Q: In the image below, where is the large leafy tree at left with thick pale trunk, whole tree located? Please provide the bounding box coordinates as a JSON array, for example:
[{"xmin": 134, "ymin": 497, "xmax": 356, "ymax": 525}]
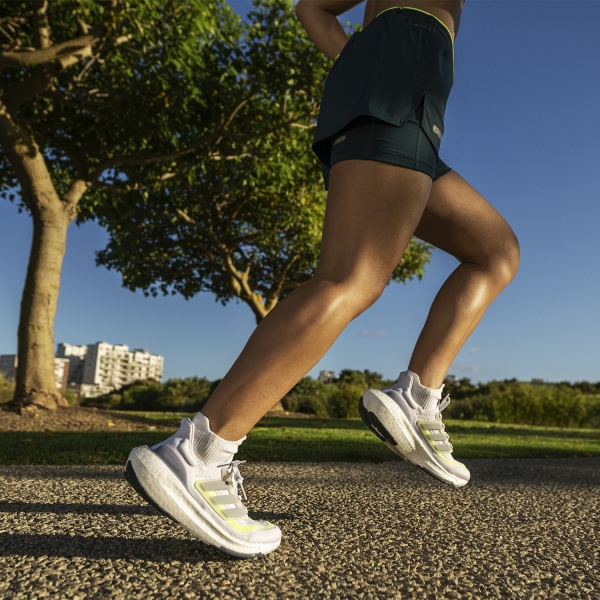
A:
[{"xmin": 0, "ymin": 0, "xmax": 282, "ymax": 408}]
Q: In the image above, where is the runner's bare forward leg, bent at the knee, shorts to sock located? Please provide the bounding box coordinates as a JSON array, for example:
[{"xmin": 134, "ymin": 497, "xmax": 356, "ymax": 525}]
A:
[{"xmin": 408, "ymin": 171, "xmax": 519, "ymax": 388}]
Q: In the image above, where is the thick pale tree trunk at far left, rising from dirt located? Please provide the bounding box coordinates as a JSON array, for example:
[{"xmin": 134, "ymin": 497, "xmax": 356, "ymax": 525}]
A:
[{"xmin": 0, "ymin": 103, "xmax": 76, "ymax": 409}]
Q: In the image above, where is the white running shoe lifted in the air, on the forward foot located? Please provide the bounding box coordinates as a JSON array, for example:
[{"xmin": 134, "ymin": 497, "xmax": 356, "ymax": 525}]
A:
[{"xmin": 359, "ymin": 371, "xmax": 471, "ymax": 487}]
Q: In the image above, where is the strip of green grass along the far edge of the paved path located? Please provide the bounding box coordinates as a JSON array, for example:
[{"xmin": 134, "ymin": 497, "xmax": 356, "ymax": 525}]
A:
[{"xmin": 0, "ymin": 412, "xmax": 600, "ymax": 465}]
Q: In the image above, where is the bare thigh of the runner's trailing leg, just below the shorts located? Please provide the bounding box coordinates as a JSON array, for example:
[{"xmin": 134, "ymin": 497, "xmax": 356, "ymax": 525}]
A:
[{"xmin": 316, "ymin": 160, "xmax": 431, "ymax": 285}]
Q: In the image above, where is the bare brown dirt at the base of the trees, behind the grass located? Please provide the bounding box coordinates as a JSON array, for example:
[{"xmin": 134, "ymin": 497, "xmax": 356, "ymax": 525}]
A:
[{"xmin": 0, "ymin": 406, "xmax": 314, "ymax": 431}]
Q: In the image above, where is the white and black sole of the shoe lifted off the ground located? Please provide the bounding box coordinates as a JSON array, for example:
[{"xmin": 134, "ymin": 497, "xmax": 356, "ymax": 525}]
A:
[{"xmin": 358, "ymin": 390, "xmax": 469, "ymax": 487}]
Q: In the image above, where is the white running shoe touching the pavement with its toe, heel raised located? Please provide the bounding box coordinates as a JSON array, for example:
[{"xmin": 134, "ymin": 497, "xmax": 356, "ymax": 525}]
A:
[{"xmin": 125, "ymin": 419, "xmax": 281, "ymax": 558}]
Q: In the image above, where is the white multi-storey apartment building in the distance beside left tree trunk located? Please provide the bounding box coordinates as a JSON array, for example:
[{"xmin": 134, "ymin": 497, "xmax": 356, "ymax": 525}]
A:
[{"xmin": 57, "ymin": 342, "xmax": 164, "ymax": 398}]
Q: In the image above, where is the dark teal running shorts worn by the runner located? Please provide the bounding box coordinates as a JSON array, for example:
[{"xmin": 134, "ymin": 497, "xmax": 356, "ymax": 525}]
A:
[{"xmin": 312, "ymin": 8, "xmax": 454, "ymax": 189}]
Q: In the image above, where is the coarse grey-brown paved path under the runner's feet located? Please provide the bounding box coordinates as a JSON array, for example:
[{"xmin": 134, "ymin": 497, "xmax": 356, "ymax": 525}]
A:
[{"xmin": 0, "ymin": 458, "xmax": 600, "ymax": 600}]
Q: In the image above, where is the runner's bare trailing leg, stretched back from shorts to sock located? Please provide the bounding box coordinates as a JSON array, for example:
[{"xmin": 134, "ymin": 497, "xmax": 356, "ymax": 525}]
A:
[{"xmin": 202, "ymin": 160, "xmax": 432, "ymax": 440}]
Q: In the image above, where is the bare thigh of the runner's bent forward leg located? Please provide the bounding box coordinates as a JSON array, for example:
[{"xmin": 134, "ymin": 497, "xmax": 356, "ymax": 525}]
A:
[{"xmin": 414, "ymin": 171, "xmax": 519, "ymax": 270}]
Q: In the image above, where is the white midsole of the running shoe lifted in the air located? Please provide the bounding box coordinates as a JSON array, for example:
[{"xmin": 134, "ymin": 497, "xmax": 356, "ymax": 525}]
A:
[{"xmin": 362, "ymin": 390, "xmax": 468, "ymax": 487}]
